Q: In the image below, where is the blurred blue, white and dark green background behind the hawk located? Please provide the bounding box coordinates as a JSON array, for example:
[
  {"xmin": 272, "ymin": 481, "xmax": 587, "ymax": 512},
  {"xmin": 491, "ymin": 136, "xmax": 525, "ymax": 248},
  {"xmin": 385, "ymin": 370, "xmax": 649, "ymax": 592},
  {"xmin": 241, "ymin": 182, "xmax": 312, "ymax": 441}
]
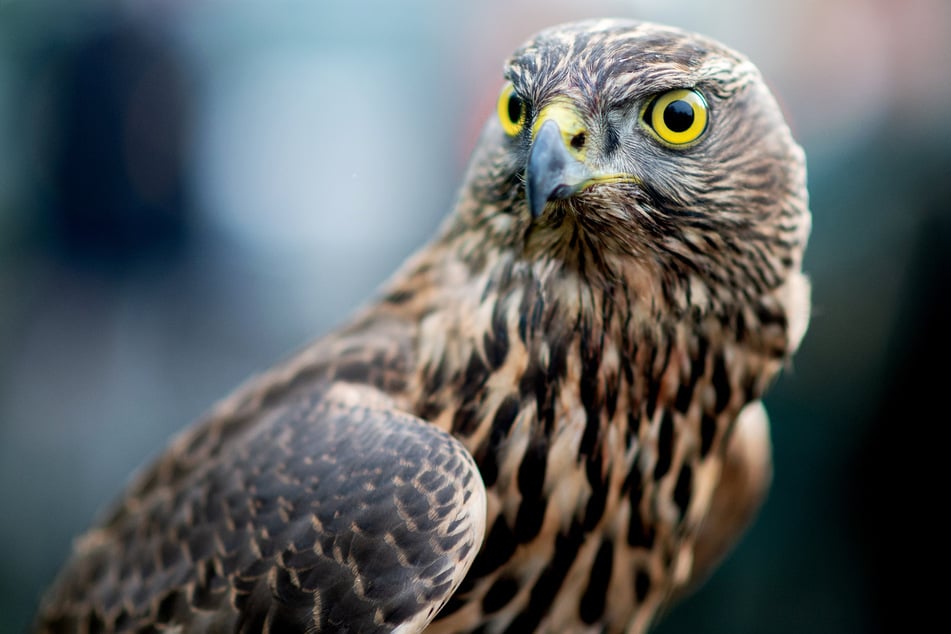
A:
[{"xmin": 0, "ymin": 0, "xmax": 951, "ymax": 634}]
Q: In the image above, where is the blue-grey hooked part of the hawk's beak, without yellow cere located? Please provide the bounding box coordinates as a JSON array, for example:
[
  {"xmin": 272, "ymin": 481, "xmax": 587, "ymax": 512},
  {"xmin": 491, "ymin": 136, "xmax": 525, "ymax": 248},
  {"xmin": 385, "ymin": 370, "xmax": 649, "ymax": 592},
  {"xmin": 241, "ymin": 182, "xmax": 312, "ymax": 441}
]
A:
[{"xmin": 525, "ymin": 118, "xmax": 593, "ymax": 218}]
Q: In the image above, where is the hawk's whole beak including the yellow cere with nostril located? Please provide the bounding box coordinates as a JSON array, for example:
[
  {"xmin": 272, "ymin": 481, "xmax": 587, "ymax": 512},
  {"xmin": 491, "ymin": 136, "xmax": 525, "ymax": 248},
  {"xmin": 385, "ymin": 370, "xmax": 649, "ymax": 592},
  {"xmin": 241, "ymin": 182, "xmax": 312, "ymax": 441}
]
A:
[{"xmin": 525, "ymin": 103, "xmax": 593, "ymax": 218}]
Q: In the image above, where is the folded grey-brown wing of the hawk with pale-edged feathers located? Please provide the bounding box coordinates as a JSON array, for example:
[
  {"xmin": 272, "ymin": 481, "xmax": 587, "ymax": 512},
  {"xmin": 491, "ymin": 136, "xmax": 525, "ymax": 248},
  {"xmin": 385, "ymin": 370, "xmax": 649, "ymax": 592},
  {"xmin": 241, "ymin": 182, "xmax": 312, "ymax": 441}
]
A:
[{"xmin": 39, "ymin": 384, "xmax": 485, "ymax": 632}]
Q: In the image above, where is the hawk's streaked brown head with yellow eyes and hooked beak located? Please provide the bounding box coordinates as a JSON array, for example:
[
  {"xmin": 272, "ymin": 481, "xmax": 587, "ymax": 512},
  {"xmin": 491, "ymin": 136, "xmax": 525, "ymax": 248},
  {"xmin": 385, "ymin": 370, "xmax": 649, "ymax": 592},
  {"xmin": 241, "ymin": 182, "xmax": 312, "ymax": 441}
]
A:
[{"xmin": 451, "ymin": 20, "xmax": 810, "ymax": 326}]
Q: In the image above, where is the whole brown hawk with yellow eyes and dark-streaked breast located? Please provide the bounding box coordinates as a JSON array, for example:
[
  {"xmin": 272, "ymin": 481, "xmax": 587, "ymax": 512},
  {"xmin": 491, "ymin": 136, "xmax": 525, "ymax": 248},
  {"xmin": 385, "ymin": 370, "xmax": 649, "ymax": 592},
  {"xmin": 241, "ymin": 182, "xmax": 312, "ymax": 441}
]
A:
[{"xmin": 35, "ymin": 20, "xmax": 811, "ymax": 633}]
